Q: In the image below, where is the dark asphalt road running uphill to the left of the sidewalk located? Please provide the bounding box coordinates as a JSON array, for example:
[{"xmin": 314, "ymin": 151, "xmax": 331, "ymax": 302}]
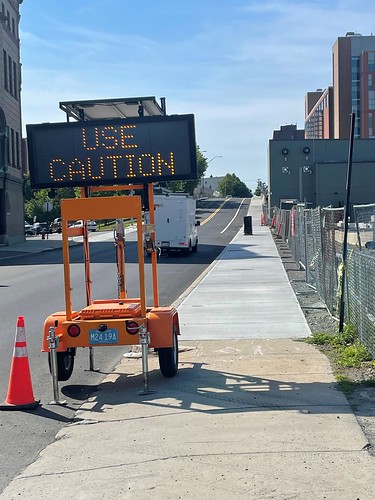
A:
[{"xmin": 0, "ymin": 198, "xmax": 253, "ymax": 492}]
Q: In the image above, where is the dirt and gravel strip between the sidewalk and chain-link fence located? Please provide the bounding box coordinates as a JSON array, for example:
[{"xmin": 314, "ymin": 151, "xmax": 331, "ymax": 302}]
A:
[{"xmin": 275, "ymin": 233, "xmax": 375, "ymax": 456}]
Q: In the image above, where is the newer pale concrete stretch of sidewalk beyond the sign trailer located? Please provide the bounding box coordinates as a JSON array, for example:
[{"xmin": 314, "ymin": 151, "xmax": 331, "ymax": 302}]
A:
[{"xmin": 179, "ymin": 199, "xmax": 310, "ymax": 340}]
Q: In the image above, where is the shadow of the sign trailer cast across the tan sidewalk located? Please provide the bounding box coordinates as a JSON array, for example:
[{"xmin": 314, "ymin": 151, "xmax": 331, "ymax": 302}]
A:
[{"xmin": 68, "ymin": 363, "xmax": 352, "ymax": 419}]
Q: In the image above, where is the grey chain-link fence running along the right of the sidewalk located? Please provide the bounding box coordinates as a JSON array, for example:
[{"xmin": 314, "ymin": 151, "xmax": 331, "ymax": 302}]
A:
[{"xmin": 269, "ymin": 204, "xmax": 375, "ymax": 356}]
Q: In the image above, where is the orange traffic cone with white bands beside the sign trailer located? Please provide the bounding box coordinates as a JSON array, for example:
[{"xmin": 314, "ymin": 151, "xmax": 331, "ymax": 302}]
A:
[{"xmin": 0, "ymin": 316, "xmax": 39, "ymax": 410}]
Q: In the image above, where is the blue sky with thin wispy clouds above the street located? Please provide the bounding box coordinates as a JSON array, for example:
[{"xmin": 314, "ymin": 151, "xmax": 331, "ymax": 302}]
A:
[{"xmin": 20, "ymin": 0, "xmax": 375, "ymax": 189}]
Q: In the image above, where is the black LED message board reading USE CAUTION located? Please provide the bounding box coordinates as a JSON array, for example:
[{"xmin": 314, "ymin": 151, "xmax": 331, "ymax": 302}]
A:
[{"xmin": 26, "ymin": 115, "xmax": 197, "ymax": 189}]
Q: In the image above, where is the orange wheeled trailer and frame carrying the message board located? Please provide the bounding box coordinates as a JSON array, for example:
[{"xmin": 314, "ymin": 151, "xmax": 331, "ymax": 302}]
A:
[{"xmin": 42, "ymin": 184, "xmax": 180, "ymax": 383}]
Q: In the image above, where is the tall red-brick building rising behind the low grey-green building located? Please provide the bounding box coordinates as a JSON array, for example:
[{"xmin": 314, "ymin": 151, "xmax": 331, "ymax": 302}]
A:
[{"xmin": 305, "ymin": 31, "xmax": 375, "ymax": 139}]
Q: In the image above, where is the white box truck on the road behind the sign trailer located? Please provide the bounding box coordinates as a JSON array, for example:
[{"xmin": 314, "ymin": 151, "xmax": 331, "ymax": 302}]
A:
[{"xmin": 146, "ymin": 193, "xmax": 199, "ymax": 252}]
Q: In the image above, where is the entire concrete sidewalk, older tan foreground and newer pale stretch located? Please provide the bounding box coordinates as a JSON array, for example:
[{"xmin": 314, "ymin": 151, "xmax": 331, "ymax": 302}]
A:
[{"xmin": 0, "ymin": 200, "xmax": 375, "ymax": 500}]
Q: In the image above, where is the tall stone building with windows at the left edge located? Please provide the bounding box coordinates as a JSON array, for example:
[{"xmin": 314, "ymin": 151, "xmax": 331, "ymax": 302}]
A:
[{"xmin": 0, "ymin": 0, "xmax": 25, "ymax": 245}]
